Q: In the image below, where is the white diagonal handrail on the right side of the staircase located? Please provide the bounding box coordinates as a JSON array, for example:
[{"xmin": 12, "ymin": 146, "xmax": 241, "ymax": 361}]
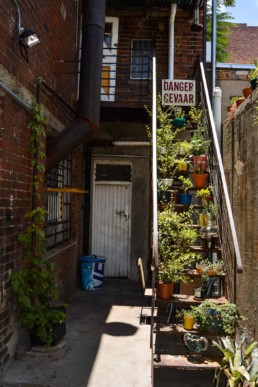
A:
[{"xmin": 200, "ymin": 63, "xmax": 243, "ymax": 273}]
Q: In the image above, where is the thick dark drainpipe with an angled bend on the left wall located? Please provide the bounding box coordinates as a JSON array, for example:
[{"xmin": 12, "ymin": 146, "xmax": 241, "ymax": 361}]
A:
[{"xmin": 46, "ymin": 0, "xmax": 106, "ymax": 171}]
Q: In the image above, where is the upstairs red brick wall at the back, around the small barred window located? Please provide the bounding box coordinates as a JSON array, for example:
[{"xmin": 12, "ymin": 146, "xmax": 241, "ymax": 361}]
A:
[{"xmin": 107, "ymin": 8, "xmax": 203, "ymax": 99}]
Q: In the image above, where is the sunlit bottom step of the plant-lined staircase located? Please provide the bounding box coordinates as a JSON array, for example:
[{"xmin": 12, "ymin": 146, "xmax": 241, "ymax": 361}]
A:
[{"xmin": 153, "ymin": 355, "xmax": 220, "ymax": 370}]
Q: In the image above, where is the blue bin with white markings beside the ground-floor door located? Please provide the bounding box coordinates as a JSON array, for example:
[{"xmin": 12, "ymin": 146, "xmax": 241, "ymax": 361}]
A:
[{"xmin": 80, "ymin": 255, "xmax": 106, "ymax": 291}]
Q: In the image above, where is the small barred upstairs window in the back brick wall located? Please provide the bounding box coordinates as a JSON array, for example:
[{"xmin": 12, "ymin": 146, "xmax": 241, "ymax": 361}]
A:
[{"xmin": 131, "ymin": 40, "xmax": 153, "ymax": 79}]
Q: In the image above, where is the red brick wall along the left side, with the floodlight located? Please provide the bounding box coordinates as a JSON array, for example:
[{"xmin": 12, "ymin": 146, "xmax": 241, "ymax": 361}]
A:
[{"xmin": 0, "ymin": 0, "xmax": 84, "ymax": 371}]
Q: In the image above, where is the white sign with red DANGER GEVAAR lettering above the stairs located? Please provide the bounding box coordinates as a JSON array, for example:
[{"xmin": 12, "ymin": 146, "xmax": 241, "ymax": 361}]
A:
[{"xmin": 162, "ymin": 79, "xmax": 195, "ymax": 106}]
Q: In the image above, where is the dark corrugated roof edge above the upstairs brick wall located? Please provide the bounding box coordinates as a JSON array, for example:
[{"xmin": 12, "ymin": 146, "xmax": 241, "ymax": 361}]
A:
[{"xmin": 106, "ymin": 0, "xmax": 204, "ymax": 8}]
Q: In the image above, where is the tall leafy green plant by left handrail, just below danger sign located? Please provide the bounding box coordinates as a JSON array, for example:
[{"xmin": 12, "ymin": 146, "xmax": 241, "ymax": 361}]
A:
[{"xmin": 145, "ymin": 94, "xmax": 181, "ymax": 178}]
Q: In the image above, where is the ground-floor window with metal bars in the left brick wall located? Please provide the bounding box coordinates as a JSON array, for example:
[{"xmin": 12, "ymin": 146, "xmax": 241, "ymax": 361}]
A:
[{"xmin": 45, "ymin": 158, "xmax": 72, "ymax": 248}]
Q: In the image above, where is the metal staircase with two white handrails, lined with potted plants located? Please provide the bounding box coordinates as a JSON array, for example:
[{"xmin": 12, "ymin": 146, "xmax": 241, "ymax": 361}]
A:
[{"xmin": 150, "ymin": 58, "xmax": 242, "ymax": 386}]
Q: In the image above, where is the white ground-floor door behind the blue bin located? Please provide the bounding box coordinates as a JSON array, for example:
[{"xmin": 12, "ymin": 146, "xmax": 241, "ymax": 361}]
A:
[{"xmin": 91, "ymin": 164, "xmax": 131, "ymax": 277}]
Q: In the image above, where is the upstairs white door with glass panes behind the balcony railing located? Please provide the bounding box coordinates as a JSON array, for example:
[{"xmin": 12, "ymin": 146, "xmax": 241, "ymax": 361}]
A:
[{"xmin": 101, "ymin": 17, "xmax": 118, "ymax": 101}]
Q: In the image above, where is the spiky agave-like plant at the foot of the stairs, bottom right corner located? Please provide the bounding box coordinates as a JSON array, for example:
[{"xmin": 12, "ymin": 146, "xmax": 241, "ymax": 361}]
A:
[{"xmin": 213, "ymin": 335, "xmax": 258, "ymax": 387}]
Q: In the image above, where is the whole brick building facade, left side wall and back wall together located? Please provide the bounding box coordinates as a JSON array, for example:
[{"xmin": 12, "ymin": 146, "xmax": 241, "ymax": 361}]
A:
[{"xmin": 0, "ymin": 0, "xmax": 206, "ymax": 376}]
